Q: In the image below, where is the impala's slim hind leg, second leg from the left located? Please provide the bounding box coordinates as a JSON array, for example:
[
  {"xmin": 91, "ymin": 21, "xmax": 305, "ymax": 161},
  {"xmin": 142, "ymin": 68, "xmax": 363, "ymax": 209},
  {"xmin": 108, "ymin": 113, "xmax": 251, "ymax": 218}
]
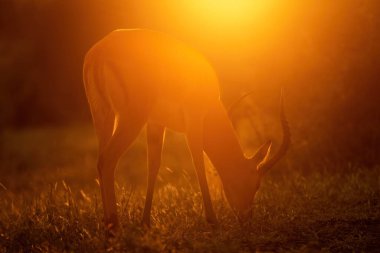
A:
[{"xmin": 142, "ymin": 124, "xmax": 165, "ymax": 227}]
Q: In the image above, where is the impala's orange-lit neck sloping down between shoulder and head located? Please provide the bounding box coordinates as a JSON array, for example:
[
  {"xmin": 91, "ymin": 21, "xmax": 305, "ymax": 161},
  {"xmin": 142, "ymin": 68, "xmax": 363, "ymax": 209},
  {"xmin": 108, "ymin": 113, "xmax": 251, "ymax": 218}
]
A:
[{"xmin": 204, "ymin": 102, "xmax": 249, "ymax": 182}]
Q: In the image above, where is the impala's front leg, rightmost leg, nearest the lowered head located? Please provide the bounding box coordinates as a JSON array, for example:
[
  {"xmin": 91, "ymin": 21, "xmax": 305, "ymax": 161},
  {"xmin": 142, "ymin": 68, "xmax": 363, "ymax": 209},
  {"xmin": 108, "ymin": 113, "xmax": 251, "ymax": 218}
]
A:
[{"xmin": 187, "ymin": 115, "xmax": 218, "ymax": 225}]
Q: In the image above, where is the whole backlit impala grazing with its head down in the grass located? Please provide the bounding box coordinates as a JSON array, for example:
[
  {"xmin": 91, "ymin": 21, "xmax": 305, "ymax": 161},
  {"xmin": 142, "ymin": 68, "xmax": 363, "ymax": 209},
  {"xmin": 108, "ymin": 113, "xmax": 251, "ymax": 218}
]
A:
[{"xmin": 83, "ymin": 29, "xmax": 290, "ymax": 227}]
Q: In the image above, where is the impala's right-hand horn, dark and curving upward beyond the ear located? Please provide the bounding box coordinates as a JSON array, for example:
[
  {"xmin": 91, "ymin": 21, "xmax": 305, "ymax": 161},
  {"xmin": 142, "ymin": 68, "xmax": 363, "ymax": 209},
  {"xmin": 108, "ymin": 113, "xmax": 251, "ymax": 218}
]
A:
[{"xmin": 257, "ymin": 89, "xmax": 291, "ymax": 175}]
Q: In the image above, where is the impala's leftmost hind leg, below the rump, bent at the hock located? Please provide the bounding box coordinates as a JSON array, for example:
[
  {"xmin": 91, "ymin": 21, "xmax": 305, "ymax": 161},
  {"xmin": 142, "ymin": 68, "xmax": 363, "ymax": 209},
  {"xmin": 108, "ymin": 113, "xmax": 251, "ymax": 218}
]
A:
[{"xmin": 98, "ymin": 115, "xmax": 145, "ymax": 229}]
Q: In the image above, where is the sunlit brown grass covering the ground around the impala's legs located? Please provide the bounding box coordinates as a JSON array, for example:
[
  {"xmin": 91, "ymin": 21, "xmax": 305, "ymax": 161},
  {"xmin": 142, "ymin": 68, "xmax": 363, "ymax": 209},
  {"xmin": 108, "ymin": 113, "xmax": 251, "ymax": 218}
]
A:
[{"xmin": 0, "ymin": 127, "xmax": 380, "ymax": 252}]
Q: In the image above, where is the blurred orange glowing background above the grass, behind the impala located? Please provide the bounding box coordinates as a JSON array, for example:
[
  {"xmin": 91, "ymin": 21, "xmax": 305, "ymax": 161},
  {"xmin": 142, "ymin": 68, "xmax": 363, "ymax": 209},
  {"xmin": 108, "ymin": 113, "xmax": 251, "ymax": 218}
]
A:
[{"xmin": 0, "ymin": 0, "xmax": 380, "ymax": 174}]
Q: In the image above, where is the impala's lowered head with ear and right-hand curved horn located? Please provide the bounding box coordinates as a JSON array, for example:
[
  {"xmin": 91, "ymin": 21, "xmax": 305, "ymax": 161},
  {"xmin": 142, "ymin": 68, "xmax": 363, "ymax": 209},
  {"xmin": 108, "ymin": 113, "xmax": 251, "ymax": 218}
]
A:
[{"xmin": 224, "ymin": 92, "xmax": 290, "ymax": 222}]
